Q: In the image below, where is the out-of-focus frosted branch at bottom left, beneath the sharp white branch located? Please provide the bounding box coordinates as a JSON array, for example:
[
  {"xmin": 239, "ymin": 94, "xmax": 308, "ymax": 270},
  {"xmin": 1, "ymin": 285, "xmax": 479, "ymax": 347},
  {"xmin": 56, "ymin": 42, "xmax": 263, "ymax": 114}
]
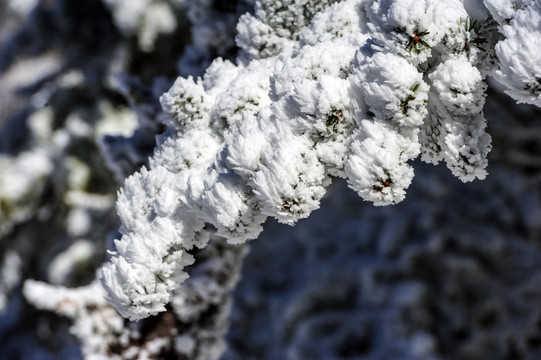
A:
[{"xmin": 23, "ymin": 237, "xmax": 247, "ymax": 360}]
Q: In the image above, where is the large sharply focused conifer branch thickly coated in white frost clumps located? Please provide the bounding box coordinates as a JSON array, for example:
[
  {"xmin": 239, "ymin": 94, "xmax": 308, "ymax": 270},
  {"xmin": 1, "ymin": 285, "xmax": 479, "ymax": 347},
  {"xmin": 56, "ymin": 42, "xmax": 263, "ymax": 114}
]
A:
[{"xmin": 101, "ymin": 0, "xmax": 540, "ymax": 320}]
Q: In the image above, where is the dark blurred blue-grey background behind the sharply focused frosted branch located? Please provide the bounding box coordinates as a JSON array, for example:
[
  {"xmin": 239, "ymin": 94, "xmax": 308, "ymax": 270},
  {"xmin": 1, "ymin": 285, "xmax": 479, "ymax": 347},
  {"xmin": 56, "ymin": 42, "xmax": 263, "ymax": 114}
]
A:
[{"xmin": 0, "ymin": 0, "xmax": 541, "ymax": 360}]
